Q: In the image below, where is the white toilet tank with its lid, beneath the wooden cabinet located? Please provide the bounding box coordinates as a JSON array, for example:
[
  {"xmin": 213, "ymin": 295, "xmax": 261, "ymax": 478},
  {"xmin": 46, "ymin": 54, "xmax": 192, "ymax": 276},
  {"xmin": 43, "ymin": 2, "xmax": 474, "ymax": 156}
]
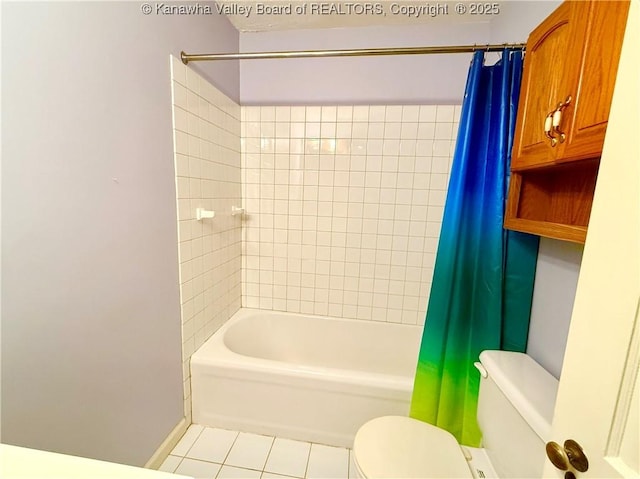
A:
[{"xmin": 478, "ymin": 351, "xmax": 558, "ymax": 478}]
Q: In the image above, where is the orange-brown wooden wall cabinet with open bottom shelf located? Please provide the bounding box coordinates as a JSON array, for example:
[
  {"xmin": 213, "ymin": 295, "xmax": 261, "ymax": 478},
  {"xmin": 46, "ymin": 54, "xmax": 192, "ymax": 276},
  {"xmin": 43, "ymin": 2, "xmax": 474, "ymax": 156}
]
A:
[{"xmin": 505, "ymin": 0, "xmax": 629, "ymax": 243}]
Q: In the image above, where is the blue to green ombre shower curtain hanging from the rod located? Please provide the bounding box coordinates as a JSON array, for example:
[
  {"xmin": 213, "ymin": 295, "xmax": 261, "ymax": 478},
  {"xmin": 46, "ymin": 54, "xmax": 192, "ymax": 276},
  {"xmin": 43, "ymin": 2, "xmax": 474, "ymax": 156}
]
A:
[{"xmin": 410, "ymin": 50, "xmax": 538, "ymax": 446}]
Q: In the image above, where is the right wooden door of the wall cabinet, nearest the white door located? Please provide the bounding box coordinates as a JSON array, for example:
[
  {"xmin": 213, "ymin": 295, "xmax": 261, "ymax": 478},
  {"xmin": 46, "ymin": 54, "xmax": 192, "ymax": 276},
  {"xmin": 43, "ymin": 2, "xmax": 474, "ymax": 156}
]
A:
[{"xmin": 556, "ymin": 1, "xmax": 629, "ymax": 162}]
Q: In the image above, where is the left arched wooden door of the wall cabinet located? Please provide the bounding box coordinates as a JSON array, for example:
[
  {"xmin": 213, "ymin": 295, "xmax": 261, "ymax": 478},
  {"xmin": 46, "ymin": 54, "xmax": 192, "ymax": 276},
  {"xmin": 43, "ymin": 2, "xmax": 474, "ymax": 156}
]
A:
[{"xmin": 511, "ymin": 2, "xmax": 584, "ymax": 170}]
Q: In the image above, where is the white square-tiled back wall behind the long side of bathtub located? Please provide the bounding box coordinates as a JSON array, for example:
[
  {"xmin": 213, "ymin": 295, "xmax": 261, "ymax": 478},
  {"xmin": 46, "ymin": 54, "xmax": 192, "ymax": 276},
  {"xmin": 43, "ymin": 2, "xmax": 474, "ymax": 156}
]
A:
[{"xmin": 242, "ymin": 105, "xmax": 460, "ymax": 324}]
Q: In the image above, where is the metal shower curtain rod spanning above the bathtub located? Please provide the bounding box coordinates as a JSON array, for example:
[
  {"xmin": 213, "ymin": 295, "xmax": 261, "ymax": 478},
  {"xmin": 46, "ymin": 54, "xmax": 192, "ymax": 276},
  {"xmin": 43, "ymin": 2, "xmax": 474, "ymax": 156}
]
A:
[{"xmin": 180, "ymin": 43, "xmax": 526, "ymax": 65}]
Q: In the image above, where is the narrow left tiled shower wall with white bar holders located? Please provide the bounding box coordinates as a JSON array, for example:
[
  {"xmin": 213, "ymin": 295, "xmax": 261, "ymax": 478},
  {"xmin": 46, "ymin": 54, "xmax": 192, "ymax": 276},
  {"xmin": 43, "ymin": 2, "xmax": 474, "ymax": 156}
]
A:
[{"xmin": 171, "ymin": 57, "xmax": 242, "ymax": 420}]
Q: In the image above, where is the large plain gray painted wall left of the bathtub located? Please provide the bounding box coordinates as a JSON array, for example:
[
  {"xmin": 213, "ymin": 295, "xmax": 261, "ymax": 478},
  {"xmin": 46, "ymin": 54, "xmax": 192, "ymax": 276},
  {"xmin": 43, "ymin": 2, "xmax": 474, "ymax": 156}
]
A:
[{"xmin": 2, "ymin": 2, "xmax": 239, "ymax": 465}]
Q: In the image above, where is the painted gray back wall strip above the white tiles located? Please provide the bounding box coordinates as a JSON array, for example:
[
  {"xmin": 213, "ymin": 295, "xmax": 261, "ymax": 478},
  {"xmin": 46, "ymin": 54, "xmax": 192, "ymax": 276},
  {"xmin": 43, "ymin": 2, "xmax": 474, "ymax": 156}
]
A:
[{"xmin": 240, "ymin": 23, "xmax": 489, "ymax": 105}]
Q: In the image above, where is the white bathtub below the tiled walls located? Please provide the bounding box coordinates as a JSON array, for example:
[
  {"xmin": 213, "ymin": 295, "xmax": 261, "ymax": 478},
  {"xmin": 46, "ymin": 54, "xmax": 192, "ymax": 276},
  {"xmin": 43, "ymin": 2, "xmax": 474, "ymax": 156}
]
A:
[{"xmin": 191, "ymin": 308, "xmax": 422, "ymax": 447}]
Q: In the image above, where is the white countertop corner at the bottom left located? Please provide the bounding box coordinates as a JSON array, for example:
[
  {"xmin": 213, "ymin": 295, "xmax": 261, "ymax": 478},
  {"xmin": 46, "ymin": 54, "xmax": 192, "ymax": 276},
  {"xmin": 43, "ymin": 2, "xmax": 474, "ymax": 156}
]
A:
[{"xmin": 0, "ymin": 444, "xmax": 193, "ymax": 479}]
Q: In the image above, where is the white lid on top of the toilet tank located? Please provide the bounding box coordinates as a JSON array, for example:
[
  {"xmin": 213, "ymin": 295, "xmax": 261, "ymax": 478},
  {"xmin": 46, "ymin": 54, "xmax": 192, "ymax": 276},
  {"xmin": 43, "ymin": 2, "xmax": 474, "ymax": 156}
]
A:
[{"xmin": 480, "ymin": 351, "xmax": 558, "ymax": 442}]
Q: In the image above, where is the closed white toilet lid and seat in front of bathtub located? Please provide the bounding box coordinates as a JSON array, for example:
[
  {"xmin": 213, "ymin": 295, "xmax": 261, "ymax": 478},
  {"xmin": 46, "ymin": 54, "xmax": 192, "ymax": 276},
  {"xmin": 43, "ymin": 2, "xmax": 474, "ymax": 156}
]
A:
[{"xmin": 353, "ymin": 416, "xmax": 473, "ymax": 479}]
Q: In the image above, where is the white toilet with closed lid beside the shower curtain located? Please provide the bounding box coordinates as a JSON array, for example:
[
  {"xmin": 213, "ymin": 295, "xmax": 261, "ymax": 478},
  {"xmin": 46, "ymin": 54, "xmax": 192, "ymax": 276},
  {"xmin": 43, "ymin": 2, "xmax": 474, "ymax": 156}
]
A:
[{"xmin": 353, "ymin": 351, "xmax": 558, "ymax": 479}]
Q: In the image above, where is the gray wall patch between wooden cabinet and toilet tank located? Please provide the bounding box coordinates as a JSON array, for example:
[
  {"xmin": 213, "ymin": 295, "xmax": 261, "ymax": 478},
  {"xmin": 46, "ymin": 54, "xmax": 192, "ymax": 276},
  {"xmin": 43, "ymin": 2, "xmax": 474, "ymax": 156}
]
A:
[{"xmin": 527, "ymin": 238, "xmax": 584, "ymax": 378}]
